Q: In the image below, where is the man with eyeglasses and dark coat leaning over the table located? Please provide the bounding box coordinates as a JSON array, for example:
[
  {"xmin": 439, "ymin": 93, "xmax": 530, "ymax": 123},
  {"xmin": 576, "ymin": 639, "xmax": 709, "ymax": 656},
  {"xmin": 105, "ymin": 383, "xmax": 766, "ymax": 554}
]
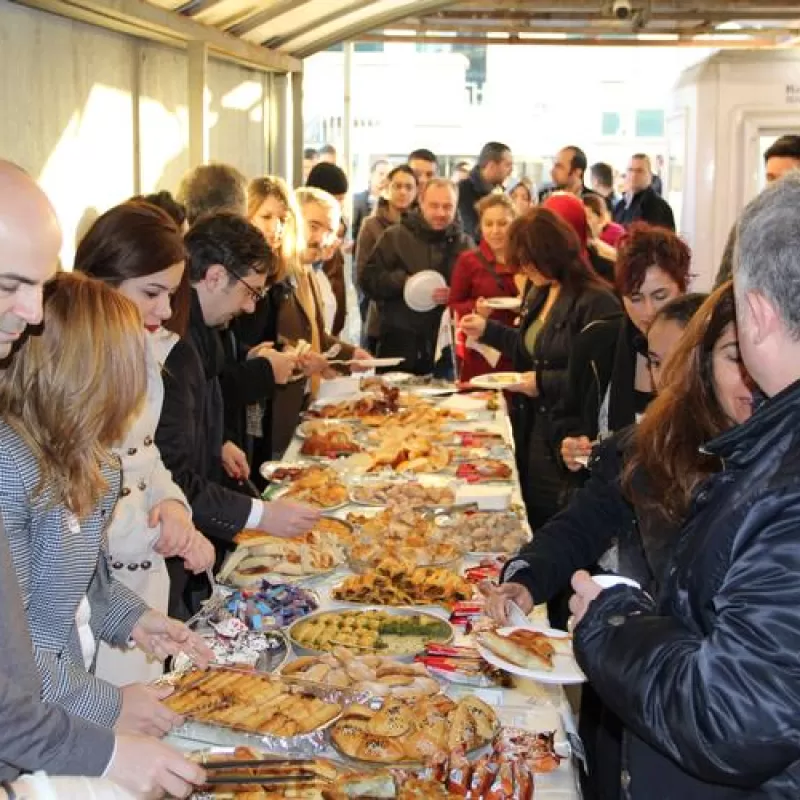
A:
[{"xmin": 156, "ymin": 212, "xmax": 319, "ymax": 618}]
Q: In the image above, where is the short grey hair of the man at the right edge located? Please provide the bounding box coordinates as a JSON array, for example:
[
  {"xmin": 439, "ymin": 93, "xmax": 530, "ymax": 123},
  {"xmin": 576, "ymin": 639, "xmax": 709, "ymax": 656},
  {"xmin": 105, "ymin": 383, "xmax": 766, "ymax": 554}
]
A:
[{"xmin": 733, "ymin": 170, "xmax": 800, "ymax": 340}]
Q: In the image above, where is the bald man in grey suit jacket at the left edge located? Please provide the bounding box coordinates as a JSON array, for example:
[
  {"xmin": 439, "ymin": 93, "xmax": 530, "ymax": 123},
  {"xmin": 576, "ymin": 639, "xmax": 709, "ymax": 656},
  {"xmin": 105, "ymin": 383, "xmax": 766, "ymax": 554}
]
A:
[{"xmin": 0, "ymin": 160, "xmax": 203, "ymax": 797}]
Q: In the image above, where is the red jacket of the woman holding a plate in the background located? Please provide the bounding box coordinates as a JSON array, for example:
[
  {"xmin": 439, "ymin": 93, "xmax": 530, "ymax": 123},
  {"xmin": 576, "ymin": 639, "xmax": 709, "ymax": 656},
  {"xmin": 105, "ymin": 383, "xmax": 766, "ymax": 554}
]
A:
[{"xmin": 449, "ymin": 241, "xmax": 518, "ymax": 381}]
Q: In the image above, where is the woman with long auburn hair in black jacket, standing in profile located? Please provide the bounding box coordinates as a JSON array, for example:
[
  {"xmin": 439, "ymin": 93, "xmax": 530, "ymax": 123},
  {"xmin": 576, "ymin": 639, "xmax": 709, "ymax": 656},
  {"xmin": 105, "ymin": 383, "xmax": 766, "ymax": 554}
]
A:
[{"xmin": 461, "ymin": 206, "xmax": 619, "ymax": 528}]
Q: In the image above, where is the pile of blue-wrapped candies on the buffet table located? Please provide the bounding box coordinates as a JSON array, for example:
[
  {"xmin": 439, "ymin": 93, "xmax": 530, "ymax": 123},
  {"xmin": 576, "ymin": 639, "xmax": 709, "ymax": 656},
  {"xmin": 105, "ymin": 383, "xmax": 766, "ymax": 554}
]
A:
[{"xmin": 226, "ymin": 580, "xmax": 319, "ymax": 632}]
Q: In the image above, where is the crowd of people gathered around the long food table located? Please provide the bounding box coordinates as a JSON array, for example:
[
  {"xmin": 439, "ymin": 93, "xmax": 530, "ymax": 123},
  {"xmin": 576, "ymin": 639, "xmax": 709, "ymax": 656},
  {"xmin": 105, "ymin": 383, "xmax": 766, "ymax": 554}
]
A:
[{"xmin": 0, "ymin": 131, "xmax": 800, "ymax": 800}]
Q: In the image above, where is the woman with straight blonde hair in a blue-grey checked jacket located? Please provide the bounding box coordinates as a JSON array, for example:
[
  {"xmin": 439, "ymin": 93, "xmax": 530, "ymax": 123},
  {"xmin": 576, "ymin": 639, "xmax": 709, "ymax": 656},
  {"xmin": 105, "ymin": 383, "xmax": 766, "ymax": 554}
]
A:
[{"xmin": 0, "ymin": 273, "xmax": 210, "ymax": 735}]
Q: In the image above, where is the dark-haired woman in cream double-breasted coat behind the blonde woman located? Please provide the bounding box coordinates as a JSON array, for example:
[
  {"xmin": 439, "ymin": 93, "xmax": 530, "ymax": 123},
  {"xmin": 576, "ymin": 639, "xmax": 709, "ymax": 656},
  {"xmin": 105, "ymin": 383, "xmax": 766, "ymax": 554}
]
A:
[{"xmin": 75, "ymin": 201, "xmax": 214, "ymax": 686}]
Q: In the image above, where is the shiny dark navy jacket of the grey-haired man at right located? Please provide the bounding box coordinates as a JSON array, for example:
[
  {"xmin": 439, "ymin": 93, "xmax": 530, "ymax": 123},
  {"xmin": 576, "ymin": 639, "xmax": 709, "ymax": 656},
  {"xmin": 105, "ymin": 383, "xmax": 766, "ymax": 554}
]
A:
[{"xmin": 575, "ymin": 382, "xmax": 800, "ymax": 800}]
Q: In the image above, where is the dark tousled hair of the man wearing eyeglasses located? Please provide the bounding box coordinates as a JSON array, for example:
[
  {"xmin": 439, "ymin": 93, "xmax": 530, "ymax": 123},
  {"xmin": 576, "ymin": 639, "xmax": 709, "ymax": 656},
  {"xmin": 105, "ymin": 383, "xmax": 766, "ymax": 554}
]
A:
[{"xmin": 184, "ymin": 211, "xmax": 277, "ymax": 283}]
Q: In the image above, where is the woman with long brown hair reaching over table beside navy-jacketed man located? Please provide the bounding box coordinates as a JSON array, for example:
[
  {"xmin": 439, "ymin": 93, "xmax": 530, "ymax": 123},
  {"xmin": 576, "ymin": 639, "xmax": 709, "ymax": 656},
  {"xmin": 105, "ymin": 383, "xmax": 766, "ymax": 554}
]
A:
[{"xmin": 483, "ymin": 283, "xmax": 753, "ymax": 800}]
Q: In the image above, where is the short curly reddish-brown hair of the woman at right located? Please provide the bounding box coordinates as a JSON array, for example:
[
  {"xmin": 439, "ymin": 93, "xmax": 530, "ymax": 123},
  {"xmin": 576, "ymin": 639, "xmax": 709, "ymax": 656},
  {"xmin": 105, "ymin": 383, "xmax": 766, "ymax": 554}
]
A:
[{"xmin": 614, "ymin": 222, "xmax": 692, "ymax": 297}]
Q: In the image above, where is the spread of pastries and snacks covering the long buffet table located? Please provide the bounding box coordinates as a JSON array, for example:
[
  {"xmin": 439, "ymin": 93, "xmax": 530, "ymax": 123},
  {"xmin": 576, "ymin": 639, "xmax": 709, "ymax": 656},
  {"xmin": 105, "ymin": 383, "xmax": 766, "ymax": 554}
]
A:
[{"xmin": 179, "ymin": 378, "xmax": 577, "ymax": 800}]
